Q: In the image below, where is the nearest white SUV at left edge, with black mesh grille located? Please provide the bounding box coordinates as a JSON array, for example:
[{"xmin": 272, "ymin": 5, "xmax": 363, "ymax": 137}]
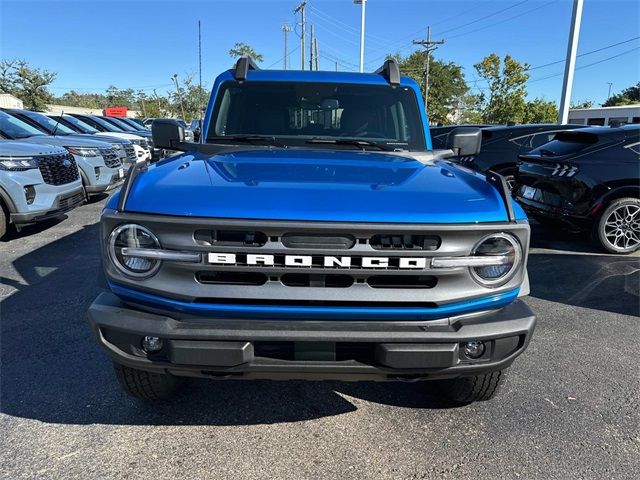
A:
[{"xmin": 0, "ymin": 140, "xmax": 85, "ymax": 238}]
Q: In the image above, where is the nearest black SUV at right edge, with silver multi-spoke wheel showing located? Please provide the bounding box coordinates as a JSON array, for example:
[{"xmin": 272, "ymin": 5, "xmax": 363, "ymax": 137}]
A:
[{"xmin": 514, "ymin": 125, "xmax": 640, "ymax": 254}]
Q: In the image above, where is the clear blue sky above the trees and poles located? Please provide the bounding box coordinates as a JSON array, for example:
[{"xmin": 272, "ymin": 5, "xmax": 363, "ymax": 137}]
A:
[{"xmin": 0, "ymin": 0, "xmax": 640, "ymax": 103}]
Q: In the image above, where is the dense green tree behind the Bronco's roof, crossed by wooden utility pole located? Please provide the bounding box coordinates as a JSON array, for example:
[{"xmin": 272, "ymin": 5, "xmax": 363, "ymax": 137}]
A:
[{"xmin": 387, "ymin": 51, "xmax": 469, "ymax": 124}]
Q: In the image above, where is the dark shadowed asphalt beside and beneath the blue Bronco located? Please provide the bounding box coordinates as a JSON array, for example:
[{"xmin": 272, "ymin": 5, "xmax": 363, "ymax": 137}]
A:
[{"xmin": 0, "ymin": 219, "xmax": 640, "ymax": 425}]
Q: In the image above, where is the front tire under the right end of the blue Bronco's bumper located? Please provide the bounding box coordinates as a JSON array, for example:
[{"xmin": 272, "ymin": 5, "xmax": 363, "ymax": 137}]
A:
[{"xmin": 438, "ymin": 370, "xmax": 505, "ymax": 405}]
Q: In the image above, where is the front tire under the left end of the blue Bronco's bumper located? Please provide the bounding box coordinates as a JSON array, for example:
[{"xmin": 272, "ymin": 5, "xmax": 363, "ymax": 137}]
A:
[{"xmin": 113, "ymin": 363, "xmax": 182, "ymax": 400}]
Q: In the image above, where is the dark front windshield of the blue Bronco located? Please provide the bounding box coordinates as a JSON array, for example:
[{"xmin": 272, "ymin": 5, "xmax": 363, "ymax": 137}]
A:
[{"xmin": 206, "ymin": 82, "xmax": 426, "ymax": 151}]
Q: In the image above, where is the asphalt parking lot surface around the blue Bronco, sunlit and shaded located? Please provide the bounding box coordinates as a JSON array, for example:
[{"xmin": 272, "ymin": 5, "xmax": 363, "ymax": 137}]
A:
[{"xmin": 0, "ymin": 199, "xmax": 640, "ymax": 479}]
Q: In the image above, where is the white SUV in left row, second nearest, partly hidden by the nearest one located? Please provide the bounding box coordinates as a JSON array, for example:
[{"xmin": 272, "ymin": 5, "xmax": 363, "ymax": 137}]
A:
[{"xmin": 0, "ymin": 111, "xmax": 124, "ymax": 195}]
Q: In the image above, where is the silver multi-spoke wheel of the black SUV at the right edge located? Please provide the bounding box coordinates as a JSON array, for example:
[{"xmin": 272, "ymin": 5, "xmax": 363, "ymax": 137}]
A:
[{"xmin": 594, "ymin": 198, "xmax": 640, "ymax": 254}]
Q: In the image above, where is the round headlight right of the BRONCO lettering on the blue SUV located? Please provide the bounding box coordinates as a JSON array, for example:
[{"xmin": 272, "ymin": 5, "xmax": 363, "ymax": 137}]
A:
[{"xmin": 470, "ymin": 233, "xmax": 522, "ymax": 287}]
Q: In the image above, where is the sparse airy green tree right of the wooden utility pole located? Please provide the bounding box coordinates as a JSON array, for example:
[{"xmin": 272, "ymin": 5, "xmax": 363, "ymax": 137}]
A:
[{"xmin": 474, "ymin": 53, "xmax": 529, "ymax": 123}]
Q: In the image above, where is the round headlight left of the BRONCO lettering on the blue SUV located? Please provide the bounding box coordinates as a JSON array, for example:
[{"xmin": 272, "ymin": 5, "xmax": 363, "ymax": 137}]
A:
[{"xmin": 108, "ymin": 223, "xmax": 160, "ymax": 278}]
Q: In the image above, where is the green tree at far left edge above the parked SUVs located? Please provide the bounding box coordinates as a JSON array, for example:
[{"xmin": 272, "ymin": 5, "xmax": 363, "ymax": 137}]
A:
[{"xmin": 0, "ymin": 60, "xmax": 57, "ymax": 111}]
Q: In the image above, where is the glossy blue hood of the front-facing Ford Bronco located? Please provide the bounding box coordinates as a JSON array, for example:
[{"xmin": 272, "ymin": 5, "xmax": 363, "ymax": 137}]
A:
[{"xmin": 117, "ymin": 149, "xmax": 526, "ymax": 223}]
